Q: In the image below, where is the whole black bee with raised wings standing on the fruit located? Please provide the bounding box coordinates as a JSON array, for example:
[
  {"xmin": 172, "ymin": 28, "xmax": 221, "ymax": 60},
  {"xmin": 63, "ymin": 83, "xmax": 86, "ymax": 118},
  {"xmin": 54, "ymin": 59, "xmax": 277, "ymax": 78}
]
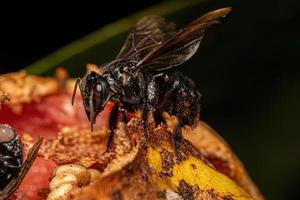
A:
[{"xmin": 72, "ymin": 7, "xmax": 231, "ymax": 152}]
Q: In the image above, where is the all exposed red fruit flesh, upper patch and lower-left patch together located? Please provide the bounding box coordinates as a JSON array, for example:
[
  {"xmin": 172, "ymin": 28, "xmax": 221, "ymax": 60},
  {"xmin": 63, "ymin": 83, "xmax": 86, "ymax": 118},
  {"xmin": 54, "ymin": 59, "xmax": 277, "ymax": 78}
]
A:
[{"xmin": 0, "ymin": 94, "xmax": 113, "ymax": 200}]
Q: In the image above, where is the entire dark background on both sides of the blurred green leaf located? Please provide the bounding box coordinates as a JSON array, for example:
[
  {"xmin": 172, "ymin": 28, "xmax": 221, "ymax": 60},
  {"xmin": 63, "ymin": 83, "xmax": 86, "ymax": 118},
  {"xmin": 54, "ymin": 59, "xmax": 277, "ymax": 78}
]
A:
[{"xmin": 0, "ymin": 0, "xmax": 300, "ymax": 199}]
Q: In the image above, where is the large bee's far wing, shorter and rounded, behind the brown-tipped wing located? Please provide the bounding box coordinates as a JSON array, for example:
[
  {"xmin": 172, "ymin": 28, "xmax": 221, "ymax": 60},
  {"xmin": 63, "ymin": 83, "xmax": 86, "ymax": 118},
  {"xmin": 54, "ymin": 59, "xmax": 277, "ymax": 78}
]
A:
[{"xmin": 104, "ymin": 16, "xmax": 176, "ymax": 70}]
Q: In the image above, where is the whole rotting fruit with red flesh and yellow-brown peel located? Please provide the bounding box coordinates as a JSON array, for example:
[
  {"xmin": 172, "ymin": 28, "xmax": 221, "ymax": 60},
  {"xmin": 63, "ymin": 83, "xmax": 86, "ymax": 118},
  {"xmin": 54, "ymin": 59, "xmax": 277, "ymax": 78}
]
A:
[{"xmin": 0, "ymin": 71, "xmax": 263, "ymax": 199}]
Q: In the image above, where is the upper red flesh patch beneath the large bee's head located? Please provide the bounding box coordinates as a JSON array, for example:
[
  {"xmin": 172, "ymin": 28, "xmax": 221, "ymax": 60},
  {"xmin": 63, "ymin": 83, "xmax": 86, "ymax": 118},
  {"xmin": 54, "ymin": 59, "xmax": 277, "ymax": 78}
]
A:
[{"xmin": 0, "ymin": 94, "xmax": 112, "ymax": 138}]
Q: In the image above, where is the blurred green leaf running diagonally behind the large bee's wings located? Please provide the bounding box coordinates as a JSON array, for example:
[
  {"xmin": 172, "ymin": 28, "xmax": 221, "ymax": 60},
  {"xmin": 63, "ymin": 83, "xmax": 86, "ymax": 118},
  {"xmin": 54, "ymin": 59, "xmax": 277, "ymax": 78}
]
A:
[{"xmin": 25, "ymin": 0, "xmax": 204, "ymax": 76}]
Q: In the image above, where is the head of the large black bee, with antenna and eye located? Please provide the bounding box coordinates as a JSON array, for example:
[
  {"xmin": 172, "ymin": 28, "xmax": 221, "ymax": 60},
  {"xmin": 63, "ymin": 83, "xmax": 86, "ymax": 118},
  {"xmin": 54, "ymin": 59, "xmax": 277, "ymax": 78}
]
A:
[{"xmin": 72, "ymin": 71, "xmax": 112, "ymax": 130}]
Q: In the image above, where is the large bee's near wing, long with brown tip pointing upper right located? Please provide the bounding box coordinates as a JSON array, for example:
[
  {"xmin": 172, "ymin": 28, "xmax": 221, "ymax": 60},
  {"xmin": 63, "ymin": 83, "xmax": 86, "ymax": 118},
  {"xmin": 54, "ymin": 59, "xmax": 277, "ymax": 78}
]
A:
[{"xmin": 136, "ymin": 7, "xmax": 231, "ymax": 72}]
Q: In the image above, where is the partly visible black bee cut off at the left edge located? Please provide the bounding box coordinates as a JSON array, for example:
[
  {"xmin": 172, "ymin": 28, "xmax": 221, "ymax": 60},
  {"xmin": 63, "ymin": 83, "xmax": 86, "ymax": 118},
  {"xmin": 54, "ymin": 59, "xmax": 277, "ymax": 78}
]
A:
[{"xmin": 0, "ymin": 124, "xmax": 43, "ymax": 200}]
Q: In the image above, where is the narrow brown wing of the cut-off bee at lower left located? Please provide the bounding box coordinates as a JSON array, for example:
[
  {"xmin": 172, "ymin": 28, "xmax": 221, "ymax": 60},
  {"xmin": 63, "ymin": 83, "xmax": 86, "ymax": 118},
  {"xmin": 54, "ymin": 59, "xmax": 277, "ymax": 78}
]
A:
[{"xmin": 0, "ymin": 138, "xmax": 43, "ymax": 200}]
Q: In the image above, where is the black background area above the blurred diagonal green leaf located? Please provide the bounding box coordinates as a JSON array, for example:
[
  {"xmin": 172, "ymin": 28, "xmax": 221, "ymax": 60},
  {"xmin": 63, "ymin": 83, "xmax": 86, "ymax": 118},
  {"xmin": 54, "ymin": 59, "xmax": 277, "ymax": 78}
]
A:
[{"xmin": 0, "ymin": 0, "xmax": 159, "ymax": 73}]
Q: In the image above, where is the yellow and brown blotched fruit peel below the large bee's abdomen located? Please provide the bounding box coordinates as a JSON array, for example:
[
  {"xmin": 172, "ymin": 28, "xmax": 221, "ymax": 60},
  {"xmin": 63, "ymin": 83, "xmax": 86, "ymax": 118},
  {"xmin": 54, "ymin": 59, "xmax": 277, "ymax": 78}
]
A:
[{"xmin": 72, "ymin": 121, "xmax": 253, "ymax": 199}]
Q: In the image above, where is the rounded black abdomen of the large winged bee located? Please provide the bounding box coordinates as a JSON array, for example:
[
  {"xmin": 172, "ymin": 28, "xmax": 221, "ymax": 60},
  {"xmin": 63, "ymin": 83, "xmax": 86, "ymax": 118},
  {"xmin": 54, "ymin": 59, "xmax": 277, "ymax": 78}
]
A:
[{"xmin": 147, "ymin": 70, "xmax": 201, "ymax": 126}]
